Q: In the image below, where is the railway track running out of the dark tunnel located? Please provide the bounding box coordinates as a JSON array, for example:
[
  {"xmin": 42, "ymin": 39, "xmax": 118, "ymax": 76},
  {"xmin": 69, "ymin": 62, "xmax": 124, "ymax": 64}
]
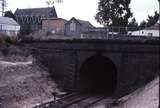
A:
[{"xmin": 33, "ymin": 93, "xmax": 114, "ymax": 108}]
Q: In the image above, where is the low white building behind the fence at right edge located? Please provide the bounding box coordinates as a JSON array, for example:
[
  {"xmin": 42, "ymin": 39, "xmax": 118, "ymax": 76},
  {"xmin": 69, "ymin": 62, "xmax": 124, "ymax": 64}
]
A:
[{"xmin": 128, "ymin": 23, "xmax": 160, "ymax": 37}]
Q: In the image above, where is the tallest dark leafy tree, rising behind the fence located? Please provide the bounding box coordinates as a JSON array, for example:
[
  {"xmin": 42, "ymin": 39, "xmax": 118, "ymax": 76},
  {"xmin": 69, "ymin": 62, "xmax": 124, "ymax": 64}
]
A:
[{"xmin": 95, "ymin": 0, "xmax": 132, "ymax": 27}]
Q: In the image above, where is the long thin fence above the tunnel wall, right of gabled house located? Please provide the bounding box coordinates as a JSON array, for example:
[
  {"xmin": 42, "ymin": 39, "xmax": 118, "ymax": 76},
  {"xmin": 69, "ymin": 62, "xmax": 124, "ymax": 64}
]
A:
[{"xmin": 83, "ymin": 27, "xmax": 160, "ymax": 37}]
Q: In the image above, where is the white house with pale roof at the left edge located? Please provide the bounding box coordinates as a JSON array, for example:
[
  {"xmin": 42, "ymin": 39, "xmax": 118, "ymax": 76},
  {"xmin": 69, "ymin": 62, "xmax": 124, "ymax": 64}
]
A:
[{"xmin": 0, "ymin": 16, "xmax": 20, "ymax": 36}]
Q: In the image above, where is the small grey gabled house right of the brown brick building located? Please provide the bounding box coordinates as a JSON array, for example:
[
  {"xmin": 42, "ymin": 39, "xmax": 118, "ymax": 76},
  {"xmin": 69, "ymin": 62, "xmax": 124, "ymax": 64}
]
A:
[{"xmin": 65, "ymin": 17, "xmax": 93, "ymax": 36}]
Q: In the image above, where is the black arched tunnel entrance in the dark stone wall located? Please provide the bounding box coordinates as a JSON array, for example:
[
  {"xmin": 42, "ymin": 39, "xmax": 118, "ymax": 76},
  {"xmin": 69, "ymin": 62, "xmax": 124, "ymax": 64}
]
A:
[{"xmin": 80, "ymin": 55, "xmax": 117, "ymax": 95}]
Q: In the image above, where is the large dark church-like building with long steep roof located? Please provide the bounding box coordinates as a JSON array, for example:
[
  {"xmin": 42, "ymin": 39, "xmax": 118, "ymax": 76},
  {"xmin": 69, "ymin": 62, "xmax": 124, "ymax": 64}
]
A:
[{"xmin": 14, "ymin": 7, "xmax": 57, "ymax": 32}]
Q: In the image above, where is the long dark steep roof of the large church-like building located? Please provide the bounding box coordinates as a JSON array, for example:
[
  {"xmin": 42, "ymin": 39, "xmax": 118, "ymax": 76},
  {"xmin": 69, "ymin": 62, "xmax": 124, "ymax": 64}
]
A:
[{"xmin": 14, "ymin": 7, "xmax": 57, "ymax": 17}]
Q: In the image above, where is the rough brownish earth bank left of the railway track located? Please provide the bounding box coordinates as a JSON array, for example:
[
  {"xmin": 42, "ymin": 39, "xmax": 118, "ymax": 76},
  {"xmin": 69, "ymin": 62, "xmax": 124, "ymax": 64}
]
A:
[{"xmin": 0, "ymin": 56, "xmax": 56, "ymax": 108}]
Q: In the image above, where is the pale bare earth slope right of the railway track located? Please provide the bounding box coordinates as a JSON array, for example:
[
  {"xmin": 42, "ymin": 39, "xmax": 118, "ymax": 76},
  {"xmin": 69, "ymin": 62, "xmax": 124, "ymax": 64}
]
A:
[{"xmin": 114, "ymin": 77, "xmax": 159, "ymax": 108}]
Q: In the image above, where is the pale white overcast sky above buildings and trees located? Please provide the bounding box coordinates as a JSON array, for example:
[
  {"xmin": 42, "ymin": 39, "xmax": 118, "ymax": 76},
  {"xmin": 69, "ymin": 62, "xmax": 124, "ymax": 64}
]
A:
[{"xmin": 1, "ymin": 0, "xmax": 159, "ymax": 26}]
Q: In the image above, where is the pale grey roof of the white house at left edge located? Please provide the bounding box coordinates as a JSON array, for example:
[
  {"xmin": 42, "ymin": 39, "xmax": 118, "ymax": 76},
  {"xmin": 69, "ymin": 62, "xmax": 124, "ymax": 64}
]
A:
[{"xmin": 0, "ymin": 16, "xmax": 19, "ymax": 26}]
